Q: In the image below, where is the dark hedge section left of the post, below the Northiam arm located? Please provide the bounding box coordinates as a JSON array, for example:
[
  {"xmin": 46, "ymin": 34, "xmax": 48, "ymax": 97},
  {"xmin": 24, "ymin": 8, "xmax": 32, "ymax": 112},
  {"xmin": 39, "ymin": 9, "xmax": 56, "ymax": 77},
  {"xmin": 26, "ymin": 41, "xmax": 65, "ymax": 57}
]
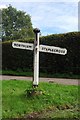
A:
[{"xmin": 2, "ymin": 39, "xmax": 33, "ymax": 71}]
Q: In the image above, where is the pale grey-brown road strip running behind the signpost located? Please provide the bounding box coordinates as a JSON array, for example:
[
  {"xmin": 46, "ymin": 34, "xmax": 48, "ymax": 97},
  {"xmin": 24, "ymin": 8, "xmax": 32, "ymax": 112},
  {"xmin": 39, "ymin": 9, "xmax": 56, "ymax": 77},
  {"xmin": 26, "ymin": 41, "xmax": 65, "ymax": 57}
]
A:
[{"xmin": 0, "ymin": 75, "xmax": 80, "ymax": 85}]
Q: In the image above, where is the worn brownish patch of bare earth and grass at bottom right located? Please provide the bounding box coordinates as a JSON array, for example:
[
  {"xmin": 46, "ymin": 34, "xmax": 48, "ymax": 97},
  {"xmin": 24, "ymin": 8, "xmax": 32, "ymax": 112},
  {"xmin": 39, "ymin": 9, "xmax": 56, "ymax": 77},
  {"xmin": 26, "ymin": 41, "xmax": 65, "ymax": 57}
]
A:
[{"xmin": 24, "ymin": 106, "xmax": 80, "ymax": 120}]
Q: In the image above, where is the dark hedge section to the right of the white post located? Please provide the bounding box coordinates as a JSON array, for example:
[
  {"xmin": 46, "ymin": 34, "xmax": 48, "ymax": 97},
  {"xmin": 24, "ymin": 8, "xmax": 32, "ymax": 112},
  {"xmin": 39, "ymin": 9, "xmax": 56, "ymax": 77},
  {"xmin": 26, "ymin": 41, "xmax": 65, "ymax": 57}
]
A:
[{"xmin": 40, "ymin": 32, "xmax": 80, "ymax": 74}]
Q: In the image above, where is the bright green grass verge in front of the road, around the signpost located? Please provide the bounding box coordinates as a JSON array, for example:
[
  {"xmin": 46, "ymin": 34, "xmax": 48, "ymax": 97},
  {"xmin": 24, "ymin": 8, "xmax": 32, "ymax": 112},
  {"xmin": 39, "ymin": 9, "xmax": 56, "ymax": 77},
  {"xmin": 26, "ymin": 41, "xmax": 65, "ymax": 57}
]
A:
[{"xmin": 2, "ymin": 80, "xmax": 79, "ymax": 119}]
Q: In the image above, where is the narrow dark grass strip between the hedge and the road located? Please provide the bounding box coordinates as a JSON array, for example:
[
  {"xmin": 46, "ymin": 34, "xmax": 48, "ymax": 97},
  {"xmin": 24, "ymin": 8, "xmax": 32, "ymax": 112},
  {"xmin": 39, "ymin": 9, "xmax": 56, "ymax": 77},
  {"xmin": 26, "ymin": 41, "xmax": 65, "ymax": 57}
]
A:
[{"xmin": 0, "ymin": 69, "xmax": 80, "ymax": 79}]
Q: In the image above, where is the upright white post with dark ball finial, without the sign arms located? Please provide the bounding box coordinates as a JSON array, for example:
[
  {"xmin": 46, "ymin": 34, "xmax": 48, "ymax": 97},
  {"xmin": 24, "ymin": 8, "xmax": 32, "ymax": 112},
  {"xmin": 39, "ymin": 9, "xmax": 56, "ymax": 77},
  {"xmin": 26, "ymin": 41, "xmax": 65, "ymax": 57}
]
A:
[{"xmin": 33, "ymin": 28, "xmax": 40, "ymax": 87}]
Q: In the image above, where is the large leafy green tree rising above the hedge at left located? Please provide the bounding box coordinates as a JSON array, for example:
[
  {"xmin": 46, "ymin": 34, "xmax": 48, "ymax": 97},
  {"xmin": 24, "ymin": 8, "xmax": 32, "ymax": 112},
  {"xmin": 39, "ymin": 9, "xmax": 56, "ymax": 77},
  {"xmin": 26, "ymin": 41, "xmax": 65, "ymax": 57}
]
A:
[{"xmin": 2, "ymin": 5, "xmax": 34, "ymax": 41}]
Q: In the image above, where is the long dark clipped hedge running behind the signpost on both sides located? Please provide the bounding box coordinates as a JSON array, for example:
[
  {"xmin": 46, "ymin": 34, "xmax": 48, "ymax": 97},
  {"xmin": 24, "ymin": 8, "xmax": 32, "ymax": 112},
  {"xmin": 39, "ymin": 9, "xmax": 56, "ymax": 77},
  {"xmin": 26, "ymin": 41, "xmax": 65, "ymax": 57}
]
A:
[{"xmin": 2, "ymin": 32, "xmax": 80, "ymax": 74}]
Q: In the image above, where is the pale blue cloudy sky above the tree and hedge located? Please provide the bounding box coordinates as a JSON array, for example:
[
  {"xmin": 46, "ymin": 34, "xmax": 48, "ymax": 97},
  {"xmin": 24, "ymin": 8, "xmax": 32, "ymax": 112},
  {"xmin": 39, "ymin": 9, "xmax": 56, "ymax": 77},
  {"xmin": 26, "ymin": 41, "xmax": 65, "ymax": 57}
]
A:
[{"xmin": 0, "ymin": 0, "xmax": 78, "ymax": 36}]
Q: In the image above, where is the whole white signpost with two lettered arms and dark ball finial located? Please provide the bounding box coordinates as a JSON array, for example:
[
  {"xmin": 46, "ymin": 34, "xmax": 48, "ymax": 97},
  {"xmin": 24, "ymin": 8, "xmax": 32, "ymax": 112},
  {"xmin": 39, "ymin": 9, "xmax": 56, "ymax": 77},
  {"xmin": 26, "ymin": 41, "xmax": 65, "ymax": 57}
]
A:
[{"xmin": 12, "ymin": 28, "xmax": 67, "ymax": 87}]
